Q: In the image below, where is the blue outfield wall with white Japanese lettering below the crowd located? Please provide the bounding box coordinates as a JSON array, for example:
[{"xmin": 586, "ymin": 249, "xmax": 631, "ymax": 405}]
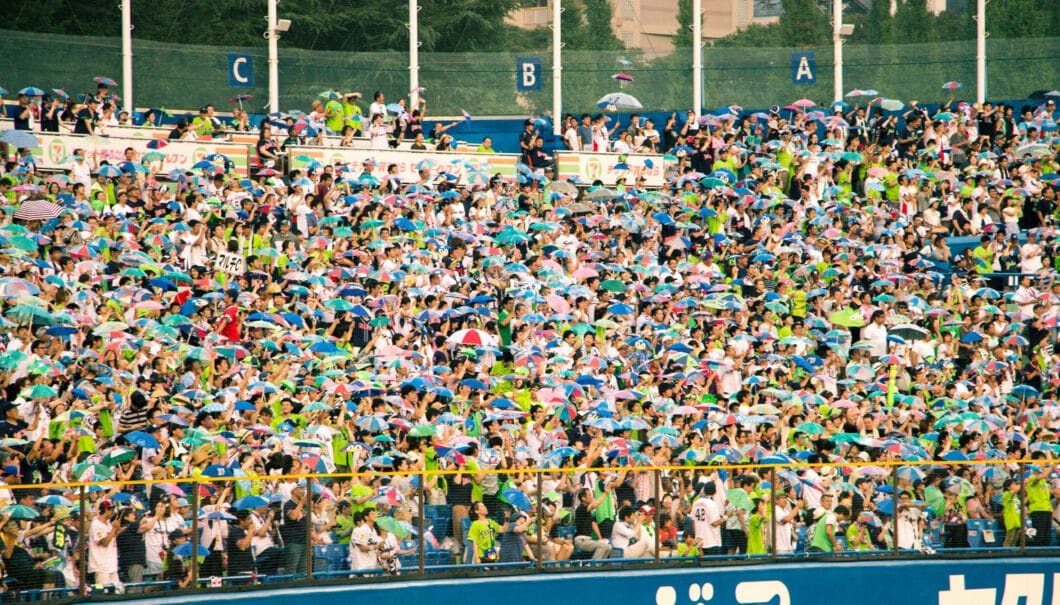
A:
[{"xmin": 127, "ymin": 557, "xmax": 1060, "ymax": 605}]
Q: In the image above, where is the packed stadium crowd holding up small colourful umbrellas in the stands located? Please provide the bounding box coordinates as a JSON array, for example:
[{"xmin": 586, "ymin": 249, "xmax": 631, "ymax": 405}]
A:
[{"xmin": 0, "ymin": 77, "xmax": 1060, "ymax": 590}]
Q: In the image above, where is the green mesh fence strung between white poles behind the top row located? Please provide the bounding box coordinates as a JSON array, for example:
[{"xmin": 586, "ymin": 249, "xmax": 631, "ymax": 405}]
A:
[{"xmin": 0, "ymin": 31, "xmax": 1060, "ymax": 115}]
